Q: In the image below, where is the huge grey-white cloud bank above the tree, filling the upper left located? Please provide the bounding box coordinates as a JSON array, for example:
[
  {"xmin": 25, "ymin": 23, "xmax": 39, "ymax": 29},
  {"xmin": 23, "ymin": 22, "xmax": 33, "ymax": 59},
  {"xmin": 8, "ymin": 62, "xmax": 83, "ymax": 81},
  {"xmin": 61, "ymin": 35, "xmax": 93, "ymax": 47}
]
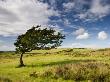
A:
[{"xmin": 0, "ymin": 0, "xmax": 58, "ymax": 36}]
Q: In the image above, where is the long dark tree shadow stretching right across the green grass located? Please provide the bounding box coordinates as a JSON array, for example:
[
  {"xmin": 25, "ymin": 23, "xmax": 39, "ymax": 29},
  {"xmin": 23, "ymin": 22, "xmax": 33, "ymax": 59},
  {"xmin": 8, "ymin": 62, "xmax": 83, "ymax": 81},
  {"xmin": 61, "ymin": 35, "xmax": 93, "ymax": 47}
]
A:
[{"xmin": 26, "ymin": 60, "xmax": 96, "ymax": 67}]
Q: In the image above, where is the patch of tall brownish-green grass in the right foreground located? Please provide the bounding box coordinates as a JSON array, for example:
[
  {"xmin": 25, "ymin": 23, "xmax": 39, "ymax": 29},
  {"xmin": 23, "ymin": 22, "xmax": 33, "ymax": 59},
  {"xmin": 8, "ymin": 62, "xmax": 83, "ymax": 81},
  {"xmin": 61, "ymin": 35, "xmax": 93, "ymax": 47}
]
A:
[{"xmin": 30, "ymin": 62, "xmax": 110, "ymax": 82}]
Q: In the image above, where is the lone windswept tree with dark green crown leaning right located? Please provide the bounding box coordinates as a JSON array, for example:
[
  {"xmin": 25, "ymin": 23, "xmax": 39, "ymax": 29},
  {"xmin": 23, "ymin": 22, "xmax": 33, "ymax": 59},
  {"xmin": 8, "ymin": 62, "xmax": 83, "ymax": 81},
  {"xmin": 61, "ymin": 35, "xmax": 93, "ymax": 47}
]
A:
[{"xmin": 14, "ymin": 26, "xmax": 65, "ymax": 66}]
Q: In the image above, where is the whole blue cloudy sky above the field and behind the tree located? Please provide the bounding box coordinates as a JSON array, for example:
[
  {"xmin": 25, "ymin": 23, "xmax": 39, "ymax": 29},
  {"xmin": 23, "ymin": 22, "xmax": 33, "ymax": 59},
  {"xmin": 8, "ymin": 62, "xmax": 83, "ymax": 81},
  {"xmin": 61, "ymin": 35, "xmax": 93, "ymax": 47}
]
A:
[{"xmin": 0, "ymin": 0, "xmax": 110, "ymax": 51}]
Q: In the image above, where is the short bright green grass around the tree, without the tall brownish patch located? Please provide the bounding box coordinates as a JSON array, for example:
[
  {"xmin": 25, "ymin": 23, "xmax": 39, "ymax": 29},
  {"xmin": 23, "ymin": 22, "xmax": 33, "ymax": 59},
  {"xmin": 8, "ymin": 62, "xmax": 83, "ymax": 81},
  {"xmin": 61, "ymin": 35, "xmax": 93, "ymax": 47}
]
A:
[{"xmin": 0, "ymin": 49, "xmax": 110, "ymax": 82}]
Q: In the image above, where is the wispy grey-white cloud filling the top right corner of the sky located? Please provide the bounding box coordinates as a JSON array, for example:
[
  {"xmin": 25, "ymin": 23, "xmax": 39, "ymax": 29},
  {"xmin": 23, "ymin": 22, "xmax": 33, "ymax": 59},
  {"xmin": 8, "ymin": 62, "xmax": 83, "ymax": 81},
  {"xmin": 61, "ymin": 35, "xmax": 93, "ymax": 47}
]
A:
[{"xmin": 75, "ymin": 0, "xmax": 110, "ymax": 22}]
